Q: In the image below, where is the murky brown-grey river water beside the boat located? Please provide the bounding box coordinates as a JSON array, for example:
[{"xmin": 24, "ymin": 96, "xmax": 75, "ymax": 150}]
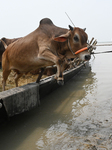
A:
[{"xmin": 0, "ymin": 46, "xmax": 112, "ymax": 150}]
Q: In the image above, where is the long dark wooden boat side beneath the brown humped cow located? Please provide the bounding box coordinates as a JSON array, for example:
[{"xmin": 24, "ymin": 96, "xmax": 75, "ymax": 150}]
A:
[{"xmin": 0, "ymin": 62, "xmax": 87, "ymax": 122}]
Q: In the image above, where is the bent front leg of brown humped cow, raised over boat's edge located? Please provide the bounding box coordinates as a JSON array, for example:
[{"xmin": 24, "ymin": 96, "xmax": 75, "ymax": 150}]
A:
[{"xmin": 38, "ymin": 50, "xmax": 64, "ymax": 85}]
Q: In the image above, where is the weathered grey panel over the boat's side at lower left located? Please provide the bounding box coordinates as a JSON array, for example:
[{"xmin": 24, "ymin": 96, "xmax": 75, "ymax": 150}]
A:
[{"xmin": 0, "ymin": 83, "xmax": 39, "ymax": 117}]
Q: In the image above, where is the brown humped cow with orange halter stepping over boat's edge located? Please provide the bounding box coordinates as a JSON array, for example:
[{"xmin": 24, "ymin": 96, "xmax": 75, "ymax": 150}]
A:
[{"xmin": 2, "ymin": 18, "xmax": 90, "ymax": 90}]
